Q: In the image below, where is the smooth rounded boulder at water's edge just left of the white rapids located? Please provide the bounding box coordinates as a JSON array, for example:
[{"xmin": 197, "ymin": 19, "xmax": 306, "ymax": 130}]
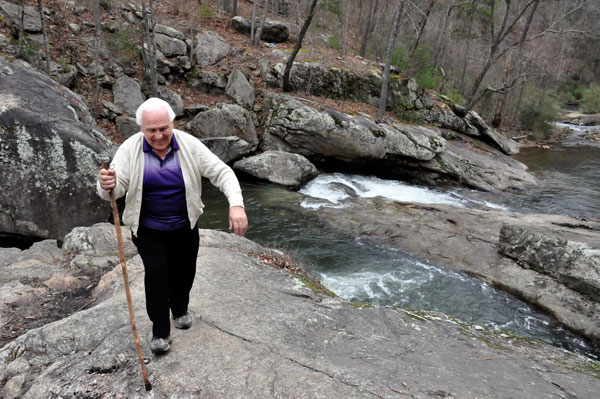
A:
[{"xmin": 233, "ymin": 151, "xmax": 319, "ymax": 187}]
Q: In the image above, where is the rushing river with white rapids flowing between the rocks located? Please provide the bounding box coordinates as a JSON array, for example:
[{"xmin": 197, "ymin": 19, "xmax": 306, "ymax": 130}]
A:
[{"xmin": 202, "ymin": 126, "xmax": 600, "ymax": 359}]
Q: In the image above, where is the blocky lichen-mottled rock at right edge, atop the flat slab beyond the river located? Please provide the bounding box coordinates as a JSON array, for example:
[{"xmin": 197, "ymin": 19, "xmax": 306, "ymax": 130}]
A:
[{"xmin": 498, "ymin": 224, "xmax": 600, "ymax": 303}]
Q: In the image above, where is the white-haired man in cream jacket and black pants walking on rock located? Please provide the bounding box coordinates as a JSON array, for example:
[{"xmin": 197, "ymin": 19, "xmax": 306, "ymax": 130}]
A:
[{"xmin": 97, "ymin": 98, "xmax": 248, "ymax": 353}]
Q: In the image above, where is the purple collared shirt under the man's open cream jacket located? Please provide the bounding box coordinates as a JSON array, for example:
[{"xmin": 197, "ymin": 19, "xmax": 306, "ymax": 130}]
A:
[{"xmin": 140, "ymin": 135, "xmax": 189, "ymax": 230}]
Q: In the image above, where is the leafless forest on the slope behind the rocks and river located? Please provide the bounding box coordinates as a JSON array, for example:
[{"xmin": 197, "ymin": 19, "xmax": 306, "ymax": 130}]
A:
[{"xmin": 8, "ymin": 0, "xmax": 600, "ymax": 138}]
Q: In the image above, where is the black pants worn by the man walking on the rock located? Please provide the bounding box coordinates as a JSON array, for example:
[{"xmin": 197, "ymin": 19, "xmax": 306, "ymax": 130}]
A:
[{"xmin": 132, "ymin": 226, "xmax": 199, "ymax": 338}]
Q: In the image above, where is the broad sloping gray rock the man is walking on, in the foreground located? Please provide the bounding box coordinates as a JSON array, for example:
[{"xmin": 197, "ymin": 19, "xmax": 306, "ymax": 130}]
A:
[{"xmin": 0, "ymin": 230, "xmax": 600, "ymax": 399}]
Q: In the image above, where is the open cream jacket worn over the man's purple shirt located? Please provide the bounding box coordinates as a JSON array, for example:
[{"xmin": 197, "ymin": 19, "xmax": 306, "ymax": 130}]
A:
[{"xmin": 96, "ymin": 129, "xmax": 244, "ymax": 234}]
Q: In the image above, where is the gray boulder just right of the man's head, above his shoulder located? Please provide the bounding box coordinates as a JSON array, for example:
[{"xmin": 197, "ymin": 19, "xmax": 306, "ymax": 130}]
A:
[{"xmin": 187, "ymin": 103, "xmax": 258, "ymax": 148}]
